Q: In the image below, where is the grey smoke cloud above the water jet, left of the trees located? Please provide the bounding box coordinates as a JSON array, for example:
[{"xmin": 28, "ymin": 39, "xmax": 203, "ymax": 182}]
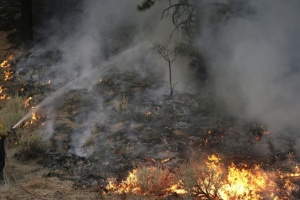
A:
[{"xmin": 43, "ymin": 0, "xmax": 175, "ymax": 83}]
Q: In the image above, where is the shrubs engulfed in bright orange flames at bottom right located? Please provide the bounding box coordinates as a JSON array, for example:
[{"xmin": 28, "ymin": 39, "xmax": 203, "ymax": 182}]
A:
[{"xmin": 174, "ymin": 155, "xmax": 297, "ymax": 200}]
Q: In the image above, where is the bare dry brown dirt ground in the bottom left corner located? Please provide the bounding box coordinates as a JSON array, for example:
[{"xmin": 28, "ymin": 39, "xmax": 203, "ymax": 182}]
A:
[{"xmin": 0, "ymin": 148, "xmax": 100, "ymax": 200}]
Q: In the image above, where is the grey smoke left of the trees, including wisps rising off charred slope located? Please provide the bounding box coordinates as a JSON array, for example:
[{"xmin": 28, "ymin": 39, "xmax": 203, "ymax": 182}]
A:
[{"xmin": 30, "ymin": 0, "xmax": 184, "ymax": 157}]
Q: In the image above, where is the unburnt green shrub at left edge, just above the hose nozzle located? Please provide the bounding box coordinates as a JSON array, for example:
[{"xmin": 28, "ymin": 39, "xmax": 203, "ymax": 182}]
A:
[{"xmin": 0, "ymin": 96, "xmax": 29, "ymax": 129}]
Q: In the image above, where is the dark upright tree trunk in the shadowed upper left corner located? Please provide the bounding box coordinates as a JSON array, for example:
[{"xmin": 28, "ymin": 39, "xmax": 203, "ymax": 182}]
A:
[{"xmin": 20, "ymin": 0, "xmax": 33, "ymax": 45}]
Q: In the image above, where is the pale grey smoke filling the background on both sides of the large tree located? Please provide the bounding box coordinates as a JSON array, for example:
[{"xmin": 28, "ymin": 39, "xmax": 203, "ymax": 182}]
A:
[{"xmin": 27, "ymin": 0, "xmax": 300, "ymax": 156}]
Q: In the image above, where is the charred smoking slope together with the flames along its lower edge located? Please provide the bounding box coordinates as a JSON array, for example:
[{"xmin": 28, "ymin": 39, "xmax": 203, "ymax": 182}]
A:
[{"xmin": 13, "ymin": 65, "xmax": 299, "ymax": 199}]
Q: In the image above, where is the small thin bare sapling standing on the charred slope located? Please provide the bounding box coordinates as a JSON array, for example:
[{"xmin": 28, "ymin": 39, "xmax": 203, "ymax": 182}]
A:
[{"xmin": 151, "ymin": 42, "xmax": 177, "ymax": 98}]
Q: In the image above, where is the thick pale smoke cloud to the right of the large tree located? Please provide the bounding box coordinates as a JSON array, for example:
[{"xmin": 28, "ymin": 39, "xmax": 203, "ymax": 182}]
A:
[{"xmin": 198, "ymin": 0, "xmax": 300, "ymax": 132}]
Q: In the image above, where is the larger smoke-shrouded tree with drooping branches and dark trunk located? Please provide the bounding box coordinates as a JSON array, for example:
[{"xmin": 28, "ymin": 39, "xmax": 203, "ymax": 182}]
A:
[{"xmin": 137, "ymin": 0, "xmax": 254, "ymax": 81}]
